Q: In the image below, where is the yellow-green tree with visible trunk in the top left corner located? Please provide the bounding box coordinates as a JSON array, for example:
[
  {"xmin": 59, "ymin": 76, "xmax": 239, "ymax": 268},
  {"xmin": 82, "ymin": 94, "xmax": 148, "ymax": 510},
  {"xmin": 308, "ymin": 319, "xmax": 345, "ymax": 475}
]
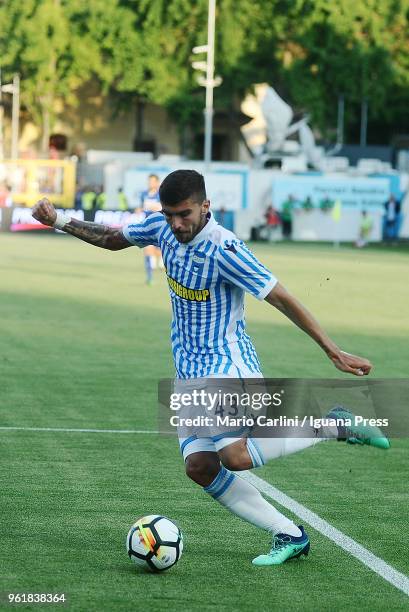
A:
[{"xmin": 0, "ymin": 0, "xmax": 142, "ymax": 152}]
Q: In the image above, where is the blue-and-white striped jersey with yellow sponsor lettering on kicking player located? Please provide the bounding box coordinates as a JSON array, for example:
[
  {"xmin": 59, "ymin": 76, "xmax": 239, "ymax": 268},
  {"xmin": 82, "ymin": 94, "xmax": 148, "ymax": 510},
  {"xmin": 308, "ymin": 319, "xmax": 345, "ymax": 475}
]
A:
[{"xmin": 122, "ymin": 213, "xmax": 277, "ymax": 378}]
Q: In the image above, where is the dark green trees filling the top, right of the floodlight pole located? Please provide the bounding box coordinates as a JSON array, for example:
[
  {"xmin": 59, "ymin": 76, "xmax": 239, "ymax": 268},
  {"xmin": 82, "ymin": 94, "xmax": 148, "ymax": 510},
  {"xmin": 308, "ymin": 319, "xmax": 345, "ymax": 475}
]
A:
[{"xmin": 216, "ymin": 0, "xmax": 409, "ymax": 141}]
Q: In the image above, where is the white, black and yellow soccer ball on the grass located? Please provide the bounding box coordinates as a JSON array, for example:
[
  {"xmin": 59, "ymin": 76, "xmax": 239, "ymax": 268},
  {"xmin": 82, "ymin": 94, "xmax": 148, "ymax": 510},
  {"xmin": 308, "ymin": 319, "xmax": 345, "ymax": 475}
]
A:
[{"xmin": 126, "ymin": 514, "xmax": 183, "ymax": 572}]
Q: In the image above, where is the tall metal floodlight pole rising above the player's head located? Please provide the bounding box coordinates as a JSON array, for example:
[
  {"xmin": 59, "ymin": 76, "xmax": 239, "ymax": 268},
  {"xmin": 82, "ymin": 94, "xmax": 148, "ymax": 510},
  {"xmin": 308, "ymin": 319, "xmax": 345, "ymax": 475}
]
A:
[{"xmin": 204, "ymin": 0, "xmax": 216, "ymax": 172}]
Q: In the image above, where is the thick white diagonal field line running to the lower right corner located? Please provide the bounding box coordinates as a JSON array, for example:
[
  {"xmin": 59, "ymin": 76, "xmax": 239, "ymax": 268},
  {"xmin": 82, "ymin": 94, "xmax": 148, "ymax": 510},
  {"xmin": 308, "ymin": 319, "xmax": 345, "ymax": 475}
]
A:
[{"xmin": 240, "ymin": 472, "xmax": 409, "ymax": 595}]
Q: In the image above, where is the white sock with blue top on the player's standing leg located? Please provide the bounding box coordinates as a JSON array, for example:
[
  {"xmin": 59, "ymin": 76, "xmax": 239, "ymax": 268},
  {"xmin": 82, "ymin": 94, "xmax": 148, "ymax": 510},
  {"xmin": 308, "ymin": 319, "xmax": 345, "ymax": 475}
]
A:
[{"xmin": 204, "ymin": 466, "xmax": 301, "ymax": 537}]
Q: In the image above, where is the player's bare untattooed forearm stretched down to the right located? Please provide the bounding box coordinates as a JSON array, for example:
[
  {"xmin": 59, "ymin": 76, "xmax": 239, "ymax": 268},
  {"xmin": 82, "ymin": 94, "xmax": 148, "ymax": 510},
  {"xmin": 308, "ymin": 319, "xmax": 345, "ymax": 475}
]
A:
[{"xmin": 266, "ymin": 286, "xmax": 340, "ymax": 357}]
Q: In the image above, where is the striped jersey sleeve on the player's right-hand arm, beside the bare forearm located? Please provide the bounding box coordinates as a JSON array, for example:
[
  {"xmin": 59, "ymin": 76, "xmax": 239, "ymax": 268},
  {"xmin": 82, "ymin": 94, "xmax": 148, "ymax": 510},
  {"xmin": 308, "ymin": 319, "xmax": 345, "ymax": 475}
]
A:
[{"xmin": 218, "ymin": 240, "xmax": 278, "ymax": 300}]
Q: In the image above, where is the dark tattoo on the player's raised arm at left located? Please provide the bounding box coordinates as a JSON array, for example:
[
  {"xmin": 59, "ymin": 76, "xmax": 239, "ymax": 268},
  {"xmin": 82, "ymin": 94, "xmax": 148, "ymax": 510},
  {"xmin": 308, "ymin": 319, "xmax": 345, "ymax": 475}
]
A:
[{"xmin": 64, "ymin": 219, "xmax": 132, "ymax": 251}]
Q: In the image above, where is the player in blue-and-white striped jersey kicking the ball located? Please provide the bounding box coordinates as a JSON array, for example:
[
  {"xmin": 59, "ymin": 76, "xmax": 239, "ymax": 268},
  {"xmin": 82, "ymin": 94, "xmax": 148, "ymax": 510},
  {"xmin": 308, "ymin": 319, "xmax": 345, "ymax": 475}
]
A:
[{"xmin": 33, "ymin": 170, "xmax": 389, "ymax": 566}]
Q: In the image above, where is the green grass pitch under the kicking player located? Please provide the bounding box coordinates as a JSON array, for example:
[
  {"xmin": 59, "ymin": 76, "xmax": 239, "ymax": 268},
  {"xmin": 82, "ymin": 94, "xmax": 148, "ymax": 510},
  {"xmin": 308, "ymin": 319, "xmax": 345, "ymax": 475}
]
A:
[{"xmin": 0, "ymin": 235, "xmax": 409, "ymax": 612}]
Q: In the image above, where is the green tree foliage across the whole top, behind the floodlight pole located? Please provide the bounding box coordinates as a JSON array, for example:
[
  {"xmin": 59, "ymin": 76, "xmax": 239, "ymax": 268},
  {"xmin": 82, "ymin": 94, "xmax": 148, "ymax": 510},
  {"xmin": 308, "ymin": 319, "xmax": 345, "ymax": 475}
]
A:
[{"xmin": 0, "ymin": 0, "xmax": 409, "ymax": 147}]
